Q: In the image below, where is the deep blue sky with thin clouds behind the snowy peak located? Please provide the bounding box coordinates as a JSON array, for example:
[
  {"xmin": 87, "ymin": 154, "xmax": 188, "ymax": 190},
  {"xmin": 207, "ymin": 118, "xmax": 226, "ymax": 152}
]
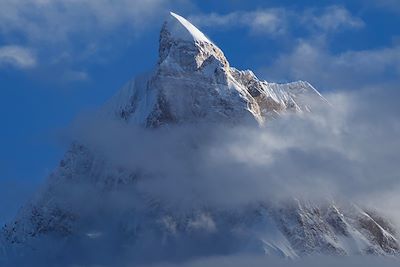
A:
[{"xmin": 0, "ymin": 0, "xmax": 400, "ymax": 221}]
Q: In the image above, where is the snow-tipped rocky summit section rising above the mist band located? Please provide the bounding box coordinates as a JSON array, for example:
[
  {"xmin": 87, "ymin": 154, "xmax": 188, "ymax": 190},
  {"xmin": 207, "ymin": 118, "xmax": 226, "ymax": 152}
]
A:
[{"xmin": 108, "ymin": 14, "xmax": 325, "ymax": 127}]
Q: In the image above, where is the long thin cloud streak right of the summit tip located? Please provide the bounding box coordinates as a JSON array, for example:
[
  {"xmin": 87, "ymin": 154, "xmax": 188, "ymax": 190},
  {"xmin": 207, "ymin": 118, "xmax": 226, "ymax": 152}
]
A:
[{"xmin": 190, "ymin": 6, "xmax": 364, "ymax": 35}]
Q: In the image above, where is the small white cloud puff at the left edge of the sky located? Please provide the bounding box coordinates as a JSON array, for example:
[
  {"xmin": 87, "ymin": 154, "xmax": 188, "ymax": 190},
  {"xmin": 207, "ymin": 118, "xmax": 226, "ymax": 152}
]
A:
[{"xmin": 0, "ymin": 46, "xmax": 37, "ymax": 69}]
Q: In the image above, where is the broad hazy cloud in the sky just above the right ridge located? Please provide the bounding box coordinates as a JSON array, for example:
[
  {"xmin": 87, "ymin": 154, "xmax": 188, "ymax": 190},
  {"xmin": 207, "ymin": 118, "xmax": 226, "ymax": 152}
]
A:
[{"xmin": 263, "ymin": 39, "xmax": 400, "ymax": 89}]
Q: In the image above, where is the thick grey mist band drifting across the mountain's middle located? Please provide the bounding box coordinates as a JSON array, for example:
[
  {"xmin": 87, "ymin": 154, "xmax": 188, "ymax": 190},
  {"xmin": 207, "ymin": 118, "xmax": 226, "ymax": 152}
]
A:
[{"xmin": 70, "ymin": 89, "xmax": 400, "ymax": 220}]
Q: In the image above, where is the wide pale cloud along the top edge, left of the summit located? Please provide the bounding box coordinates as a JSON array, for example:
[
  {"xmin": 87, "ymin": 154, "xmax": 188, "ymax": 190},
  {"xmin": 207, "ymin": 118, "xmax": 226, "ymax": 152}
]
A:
[{"xmin": 0, "ymin": 0, "xmax": 180, "ymax": 42}]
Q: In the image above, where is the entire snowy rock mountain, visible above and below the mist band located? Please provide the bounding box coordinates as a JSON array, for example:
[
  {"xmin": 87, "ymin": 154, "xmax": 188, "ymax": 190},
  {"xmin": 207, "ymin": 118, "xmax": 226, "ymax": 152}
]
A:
[{"xmin": 0, "ymin": 13, "xmax": 399, "ymax": 262}]
